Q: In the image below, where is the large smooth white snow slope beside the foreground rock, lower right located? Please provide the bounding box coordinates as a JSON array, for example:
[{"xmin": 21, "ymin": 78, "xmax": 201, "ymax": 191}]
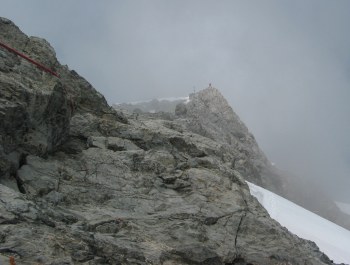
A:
[{"xmin": 247, "ymin": 182, "xmax": 350, "ymax": 264}]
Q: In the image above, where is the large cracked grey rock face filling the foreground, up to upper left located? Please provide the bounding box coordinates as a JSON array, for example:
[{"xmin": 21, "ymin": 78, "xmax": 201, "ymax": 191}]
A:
[{"xmin": 0, "ymin": 19, "xmax": 332, "ymax": 265}]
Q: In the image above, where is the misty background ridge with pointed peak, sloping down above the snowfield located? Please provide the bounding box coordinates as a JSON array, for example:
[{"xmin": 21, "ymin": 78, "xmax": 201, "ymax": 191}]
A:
[{"xmin": 115, "ymin": 86, "xmax": 350, "ymax": 230}]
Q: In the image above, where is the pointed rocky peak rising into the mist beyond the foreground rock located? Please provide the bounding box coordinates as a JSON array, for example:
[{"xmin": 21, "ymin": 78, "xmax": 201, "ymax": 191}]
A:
[{"xmin": 176, "ymin": 86, "xmax": 282, "ymax": 188}]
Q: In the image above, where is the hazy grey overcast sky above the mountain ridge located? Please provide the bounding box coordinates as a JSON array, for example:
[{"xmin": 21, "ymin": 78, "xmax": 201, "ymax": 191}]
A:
[{"xmin": 0, "ymin": 0, "xmax": 350, "ymax": 201}]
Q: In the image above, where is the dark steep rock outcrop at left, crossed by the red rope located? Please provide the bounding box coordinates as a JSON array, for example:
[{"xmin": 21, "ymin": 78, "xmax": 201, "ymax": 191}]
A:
[{"xmin": 0, "ymin": 18, "xmax": 123, "ymax": 188}]
